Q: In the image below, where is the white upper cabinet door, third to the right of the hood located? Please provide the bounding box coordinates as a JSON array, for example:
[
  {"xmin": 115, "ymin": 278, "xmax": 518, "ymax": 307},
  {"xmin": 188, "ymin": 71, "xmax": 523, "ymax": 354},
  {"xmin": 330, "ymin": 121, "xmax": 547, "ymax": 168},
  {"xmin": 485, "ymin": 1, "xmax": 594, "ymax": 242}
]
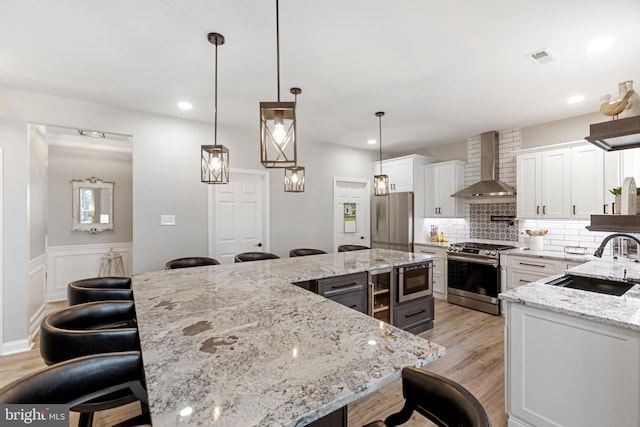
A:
[{"xmin": 571, "ymin": 145, "xmax": 604, "ymax": 219}]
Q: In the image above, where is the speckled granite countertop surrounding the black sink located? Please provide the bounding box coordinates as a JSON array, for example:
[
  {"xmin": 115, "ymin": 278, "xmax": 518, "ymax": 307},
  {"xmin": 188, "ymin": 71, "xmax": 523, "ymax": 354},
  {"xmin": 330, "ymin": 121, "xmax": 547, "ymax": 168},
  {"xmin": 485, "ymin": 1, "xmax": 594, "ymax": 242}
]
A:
[{"xmin": 499, "ymin": 258, "xmax": 640, "ymax": 331}]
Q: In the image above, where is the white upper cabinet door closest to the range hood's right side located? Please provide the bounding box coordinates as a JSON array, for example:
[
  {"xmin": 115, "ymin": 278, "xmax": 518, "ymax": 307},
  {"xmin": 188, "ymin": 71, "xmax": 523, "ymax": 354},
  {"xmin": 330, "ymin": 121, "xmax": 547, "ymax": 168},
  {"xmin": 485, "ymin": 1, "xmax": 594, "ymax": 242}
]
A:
[{"xmin": 516, "ymin": 153, "xmax": 542, "ymax": 218}]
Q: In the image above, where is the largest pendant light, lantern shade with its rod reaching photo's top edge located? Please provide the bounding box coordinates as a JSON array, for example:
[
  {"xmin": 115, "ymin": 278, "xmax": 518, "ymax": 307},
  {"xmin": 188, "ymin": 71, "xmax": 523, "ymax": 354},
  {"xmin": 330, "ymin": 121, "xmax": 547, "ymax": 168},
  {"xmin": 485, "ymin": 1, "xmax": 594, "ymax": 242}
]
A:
[{"xmin": 260, "ymin": 0, "xmax": 297, "ymax": 169}]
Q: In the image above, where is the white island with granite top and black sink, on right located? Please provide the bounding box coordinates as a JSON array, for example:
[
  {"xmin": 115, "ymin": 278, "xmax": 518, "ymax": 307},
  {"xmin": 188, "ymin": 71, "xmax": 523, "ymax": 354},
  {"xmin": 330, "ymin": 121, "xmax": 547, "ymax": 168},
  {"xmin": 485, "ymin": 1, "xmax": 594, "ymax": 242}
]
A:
[{"xmin": 500, "ymin": 258, "xmax": 640, "ymax": 427}]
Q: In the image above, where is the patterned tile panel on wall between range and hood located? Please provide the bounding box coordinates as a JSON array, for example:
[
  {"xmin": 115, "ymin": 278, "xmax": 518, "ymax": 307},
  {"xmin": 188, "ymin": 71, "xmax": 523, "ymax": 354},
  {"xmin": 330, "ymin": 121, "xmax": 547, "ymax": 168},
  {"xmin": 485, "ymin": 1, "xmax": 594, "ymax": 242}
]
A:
[{"xmin": 469, "ymin": 203, "xmax": 518, "ymax": 241}]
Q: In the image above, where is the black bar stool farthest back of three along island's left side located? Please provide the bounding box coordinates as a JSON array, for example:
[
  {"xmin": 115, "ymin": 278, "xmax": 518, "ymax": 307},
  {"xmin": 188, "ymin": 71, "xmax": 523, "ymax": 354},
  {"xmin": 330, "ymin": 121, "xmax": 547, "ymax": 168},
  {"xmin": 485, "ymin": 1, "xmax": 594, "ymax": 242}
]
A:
[{"xmin": 67, "ymin": 277, "xmax": 133, "ymax": 305}]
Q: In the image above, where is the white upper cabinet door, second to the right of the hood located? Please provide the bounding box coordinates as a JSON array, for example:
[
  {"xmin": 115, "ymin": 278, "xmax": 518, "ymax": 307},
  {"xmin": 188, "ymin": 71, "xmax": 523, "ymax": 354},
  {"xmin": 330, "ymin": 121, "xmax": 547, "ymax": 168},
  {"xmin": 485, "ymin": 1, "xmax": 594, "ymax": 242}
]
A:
[{"xmin": 541, "ymin": 148, "xmax": 571, "ymax": 219}]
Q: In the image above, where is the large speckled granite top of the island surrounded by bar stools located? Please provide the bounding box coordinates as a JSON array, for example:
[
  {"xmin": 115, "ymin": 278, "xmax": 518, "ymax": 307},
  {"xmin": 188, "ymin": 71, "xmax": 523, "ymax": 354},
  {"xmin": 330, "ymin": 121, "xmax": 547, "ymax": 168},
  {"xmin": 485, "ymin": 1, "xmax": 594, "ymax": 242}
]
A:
[{"xmin": 133, "ymin": 249, "xmax": 445, "ymax": 427}]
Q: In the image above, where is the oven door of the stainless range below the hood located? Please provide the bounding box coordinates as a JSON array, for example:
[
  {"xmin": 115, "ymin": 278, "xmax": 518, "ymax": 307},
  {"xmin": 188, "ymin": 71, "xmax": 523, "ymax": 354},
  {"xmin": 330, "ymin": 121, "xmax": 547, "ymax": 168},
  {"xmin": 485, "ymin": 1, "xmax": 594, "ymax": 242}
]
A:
[{"xmin": 447, "ymin": 255, "xmax": 500, "ymax": 315}]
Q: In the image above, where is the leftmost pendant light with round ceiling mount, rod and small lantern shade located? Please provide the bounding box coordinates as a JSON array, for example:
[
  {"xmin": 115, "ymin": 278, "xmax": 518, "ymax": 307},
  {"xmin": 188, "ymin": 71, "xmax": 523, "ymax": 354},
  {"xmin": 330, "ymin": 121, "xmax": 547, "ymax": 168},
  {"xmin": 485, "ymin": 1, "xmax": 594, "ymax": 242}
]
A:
[{"xmin": 200, "ymin": 33, "xmax": 229, "ymax": 184}]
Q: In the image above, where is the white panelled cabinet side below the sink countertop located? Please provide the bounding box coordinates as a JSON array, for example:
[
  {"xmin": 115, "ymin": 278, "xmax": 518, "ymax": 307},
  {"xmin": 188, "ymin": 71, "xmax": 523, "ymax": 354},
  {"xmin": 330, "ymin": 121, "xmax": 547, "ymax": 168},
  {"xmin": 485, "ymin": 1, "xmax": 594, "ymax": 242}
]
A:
[{"xmin": 505, "ymin": 302, "xmax": 640, "ymax": 427}]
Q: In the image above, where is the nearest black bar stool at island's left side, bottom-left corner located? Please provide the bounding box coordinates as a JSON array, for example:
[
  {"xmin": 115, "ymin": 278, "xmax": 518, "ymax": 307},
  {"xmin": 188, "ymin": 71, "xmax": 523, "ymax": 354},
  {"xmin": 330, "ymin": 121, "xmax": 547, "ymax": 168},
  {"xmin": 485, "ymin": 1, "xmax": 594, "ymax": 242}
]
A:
[{"xmin": 0, "ymin": 351, "xmax": 151, "ymax": 427}]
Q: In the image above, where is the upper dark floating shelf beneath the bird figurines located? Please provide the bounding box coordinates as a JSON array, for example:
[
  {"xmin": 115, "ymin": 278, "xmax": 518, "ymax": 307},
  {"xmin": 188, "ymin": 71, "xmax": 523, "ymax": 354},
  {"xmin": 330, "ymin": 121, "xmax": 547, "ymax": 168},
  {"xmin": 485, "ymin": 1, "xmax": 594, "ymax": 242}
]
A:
[{"xmin": 584, "ymin": 116, "xmax": 640, "ymax": 151}]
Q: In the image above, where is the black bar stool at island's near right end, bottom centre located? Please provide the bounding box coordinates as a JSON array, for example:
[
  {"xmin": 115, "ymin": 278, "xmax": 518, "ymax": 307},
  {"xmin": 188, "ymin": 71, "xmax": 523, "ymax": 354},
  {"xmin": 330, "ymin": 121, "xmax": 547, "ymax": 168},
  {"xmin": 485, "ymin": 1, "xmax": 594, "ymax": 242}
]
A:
[{"xmin": 365, "ymin": 367, "xmax": 491, "ymax": 427}]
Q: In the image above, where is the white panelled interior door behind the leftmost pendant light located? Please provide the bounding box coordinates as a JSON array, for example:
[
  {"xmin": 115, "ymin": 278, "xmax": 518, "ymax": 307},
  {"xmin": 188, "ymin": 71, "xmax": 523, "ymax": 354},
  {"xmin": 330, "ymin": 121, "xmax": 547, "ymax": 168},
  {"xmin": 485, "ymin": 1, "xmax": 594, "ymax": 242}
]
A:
[{"xmin": 209, "ymin": 170, "xmax": 270, "ymax": 264}]
